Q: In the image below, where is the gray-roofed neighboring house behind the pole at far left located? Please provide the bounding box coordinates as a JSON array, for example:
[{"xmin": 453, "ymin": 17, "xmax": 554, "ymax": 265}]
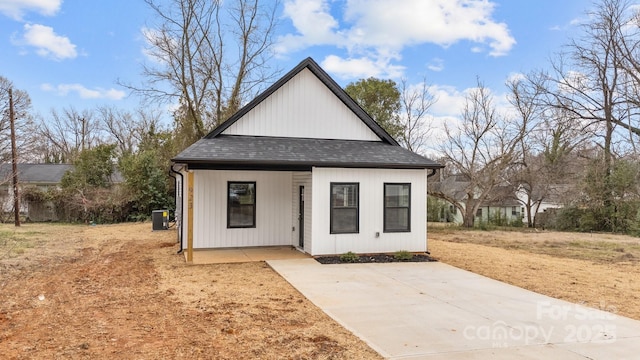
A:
[{"xmin": 0, "ymin": 164, "xmax": 73, "ymax": 221}]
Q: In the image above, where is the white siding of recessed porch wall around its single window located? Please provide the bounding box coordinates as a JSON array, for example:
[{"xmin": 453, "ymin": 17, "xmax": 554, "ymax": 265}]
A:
[{"xmin": 185, "ymin": 170, "xmax": 293, "ymax": 249}]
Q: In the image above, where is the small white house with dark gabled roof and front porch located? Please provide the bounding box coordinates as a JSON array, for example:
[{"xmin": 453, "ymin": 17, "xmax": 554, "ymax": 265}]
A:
[{"xmin": 172, "ymin": 58, "xmax": 442, "ymax": 255}]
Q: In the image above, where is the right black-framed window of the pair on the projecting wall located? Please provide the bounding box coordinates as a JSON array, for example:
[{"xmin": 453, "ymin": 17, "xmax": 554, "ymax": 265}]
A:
[{"xmin": 384, "ymin": 183, "xmax": 411, "ymax": 232}]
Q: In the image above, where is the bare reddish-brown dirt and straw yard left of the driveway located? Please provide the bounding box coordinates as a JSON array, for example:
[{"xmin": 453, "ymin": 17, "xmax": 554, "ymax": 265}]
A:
[{"xmin": 0, "ymin": 223, "xmax": 379, "ymax": 359}]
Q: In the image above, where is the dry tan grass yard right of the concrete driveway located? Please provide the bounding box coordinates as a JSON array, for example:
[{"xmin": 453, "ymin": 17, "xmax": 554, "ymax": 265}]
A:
[{"xmin": 428, "ymin": 227, "xmax": 640, "ymax": 320}]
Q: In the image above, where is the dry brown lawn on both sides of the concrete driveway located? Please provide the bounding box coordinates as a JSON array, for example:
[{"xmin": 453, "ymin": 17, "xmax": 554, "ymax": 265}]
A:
[{"xmin": 5, "ymin": 223, "xmax": 640, "ymax": 359}]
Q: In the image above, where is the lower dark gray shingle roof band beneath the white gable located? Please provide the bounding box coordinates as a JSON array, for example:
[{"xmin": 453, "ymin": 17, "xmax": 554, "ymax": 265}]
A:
[{"xmin": 172, "ymin": 135, "xmax": 442, "ymax": 170}]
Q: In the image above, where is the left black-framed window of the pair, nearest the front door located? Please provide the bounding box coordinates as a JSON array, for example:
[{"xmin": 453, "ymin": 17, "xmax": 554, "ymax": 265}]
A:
[{"xmin": 330, "ymin": 182, "xmax": 360, "ymax": 234}]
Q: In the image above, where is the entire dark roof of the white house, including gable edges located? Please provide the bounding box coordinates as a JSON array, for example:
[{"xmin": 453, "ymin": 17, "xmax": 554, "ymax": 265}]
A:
[{"xmin": 172, "ymin": 58, "xmax": 443, "ymax": 170}]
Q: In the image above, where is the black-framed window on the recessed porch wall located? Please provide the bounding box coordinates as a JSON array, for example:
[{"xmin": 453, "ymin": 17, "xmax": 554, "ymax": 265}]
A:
[{"xmin": 227, "ymin": 181, "xmax": 256, "ymax": 228}]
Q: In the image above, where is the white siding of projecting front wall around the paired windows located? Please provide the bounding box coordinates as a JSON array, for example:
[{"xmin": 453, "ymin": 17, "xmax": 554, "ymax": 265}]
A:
[{"xmin": 305, "ymin": 168, "xmax": 427, "ymax": 255}]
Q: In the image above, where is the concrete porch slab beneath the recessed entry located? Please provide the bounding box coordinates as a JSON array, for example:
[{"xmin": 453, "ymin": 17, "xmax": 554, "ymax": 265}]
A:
[{"xmin": 184, "ymin": 246, "xmax": 311, "ymax": 264}]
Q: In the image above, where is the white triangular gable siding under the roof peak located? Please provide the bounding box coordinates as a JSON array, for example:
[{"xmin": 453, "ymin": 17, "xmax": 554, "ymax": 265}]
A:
[{"xmin": 223, "ymin": 69, "xmax": 380, "ymax": 141}]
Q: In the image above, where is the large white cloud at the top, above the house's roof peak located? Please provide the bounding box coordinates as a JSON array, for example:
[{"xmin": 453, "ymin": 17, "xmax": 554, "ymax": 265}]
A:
[{"xmin": 276, "ymin": 0, "xmax": 516, "ymax": 77}]
